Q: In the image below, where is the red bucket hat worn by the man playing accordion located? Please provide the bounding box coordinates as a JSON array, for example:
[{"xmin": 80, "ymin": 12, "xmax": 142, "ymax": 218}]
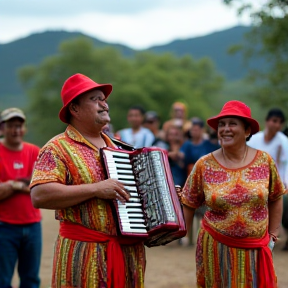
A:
[{"xmin": 59, "ymin": 73, "xmax": 112, "ymax": 123}]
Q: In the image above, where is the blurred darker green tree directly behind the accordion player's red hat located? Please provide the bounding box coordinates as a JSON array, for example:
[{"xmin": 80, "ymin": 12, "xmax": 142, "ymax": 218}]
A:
[{"xmin": 18, "ymin": 37, "xmax": 130, "ymax": 145}]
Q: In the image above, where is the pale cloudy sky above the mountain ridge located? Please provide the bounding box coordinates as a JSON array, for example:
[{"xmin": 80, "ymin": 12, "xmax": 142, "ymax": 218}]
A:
[{"xmin": 0, "ymin": 0, "xmax": 250, "ymax": 49}]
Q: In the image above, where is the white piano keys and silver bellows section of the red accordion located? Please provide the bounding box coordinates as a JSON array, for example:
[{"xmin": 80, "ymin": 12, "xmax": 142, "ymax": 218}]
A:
[{"xmin": 102, "ymin": 149, "xmax": 178, "ymax": 236}]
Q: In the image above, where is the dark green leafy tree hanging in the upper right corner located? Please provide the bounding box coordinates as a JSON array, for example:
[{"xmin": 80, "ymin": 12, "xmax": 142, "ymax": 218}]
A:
[{"xmin": 224, "ymin": 0, "xmax": 288, "ymax": 110}]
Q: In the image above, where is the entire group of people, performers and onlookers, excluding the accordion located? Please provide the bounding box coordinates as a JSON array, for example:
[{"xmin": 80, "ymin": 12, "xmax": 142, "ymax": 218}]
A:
[{"xmin": 0, "ymin": 74, "xmax": 288, "ymax": 288}]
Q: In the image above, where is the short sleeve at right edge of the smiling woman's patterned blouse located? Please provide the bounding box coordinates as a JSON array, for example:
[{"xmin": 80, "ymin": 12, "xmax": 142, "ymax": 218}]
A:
[{"xmin": 268, "ymin": 156, "xmax": 286, "ymax": 201}]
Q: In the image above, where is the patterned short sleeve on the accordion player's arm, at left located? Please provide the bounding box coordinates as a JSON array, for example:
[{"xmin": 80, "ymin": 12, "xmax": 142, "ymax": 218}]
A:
[{"xmin": 30, "ymin": 143, "xmax": 68, "ymax": 188}]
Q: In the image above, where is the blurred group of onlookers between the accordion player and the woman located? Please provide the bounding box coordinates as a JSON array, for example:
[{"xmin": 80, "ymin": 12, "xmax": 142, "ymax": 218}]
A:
[{"xmin": 111, "ymin": 102, "xmax": 220, "ymax": 186}]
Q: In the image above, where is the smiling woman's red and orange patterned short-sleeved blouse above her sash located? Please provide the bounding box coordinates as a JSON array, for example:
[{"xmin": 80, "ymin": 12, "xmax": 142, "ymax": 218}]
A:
[{"xmin": 183, "ymin": 150, "xmax": 285, "ymax": 238}]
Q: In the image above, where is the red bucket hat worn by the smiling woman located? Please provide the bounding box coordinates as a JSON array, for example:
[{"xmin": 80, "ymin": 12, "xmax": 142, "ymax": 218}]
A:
[{"xmin": 207, "ymin": 100, "xmax": 259, "ymax": 134}]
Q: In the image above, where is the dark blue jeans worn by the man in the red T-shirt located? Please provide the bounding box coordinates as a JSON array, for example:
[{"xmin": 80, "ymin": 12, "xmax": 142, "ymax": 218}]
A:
[{"xmin": 0, "ymin": 222, "xmax": 42, "ymax": 288}]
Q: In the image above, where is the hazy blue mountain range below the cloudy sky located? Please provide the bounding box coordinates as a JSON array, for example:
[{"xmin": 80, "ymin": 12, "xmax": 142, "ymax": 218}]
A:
[{"xmin": 0, "ymin": 26, "xmax": 265, "ymax": 106}]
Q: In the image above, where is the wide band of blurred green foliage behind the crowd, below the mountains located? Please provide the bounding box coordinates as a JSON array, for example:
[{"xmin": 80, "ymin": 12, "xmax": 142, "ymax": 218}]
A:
[{"xmin": 19, "ymin": 38, "xmax": 224, "ymax": 145}]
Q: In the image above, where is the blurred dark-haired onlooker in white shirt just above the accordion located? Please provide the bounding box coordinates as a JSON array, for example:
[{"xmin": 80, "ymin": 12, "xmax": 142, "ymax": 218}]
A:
[{"xmin": 116, "ymin": 105, "xmax": 155, "ymax": 148}]
